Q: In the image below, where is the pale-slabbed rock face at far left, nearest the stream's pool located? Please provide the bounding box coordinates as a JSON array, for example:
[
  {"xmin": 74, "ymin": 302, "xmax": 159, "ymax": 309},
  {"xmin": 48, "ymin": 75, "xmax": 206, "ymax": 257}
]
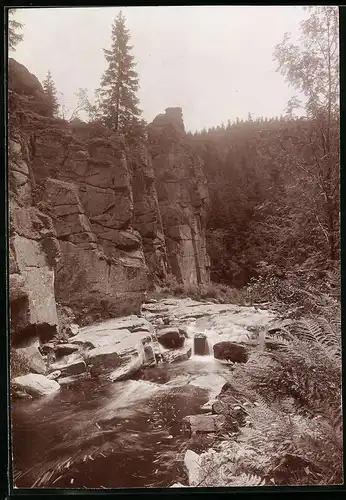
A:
[{"xmin": 9, "ymin": 137, "xmax": 60, "ymax": 345}]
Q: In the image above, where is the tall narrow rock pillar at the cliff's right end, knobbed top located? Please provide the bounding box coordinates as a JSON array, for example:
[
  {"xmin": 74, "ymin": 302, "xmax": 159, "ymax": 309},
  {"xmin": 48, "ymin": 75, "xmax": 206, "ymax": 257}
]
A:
[{"xmin": 148, "ymin": 108, "xmax": 209, "ymax": 285}]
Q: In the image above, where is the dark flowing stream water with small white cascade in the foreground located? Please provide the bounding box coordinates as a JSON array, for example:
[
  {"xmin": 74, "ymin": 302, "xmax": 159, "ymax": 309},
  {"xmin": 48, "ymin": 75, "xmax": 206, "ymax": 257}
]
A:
[{"xmin": 12, "ymin": 330, "xmax": 234, "ymax": 488}]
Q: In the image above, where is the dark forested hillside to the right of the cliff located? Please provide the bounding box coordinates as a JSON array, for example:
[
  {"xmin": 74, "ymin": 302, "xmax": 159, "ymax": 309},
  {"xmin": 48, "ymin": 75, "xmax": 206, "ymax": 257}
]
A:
[{"xmin": 190, "ymin": 113, "xmax": 339, "ymax": 287}]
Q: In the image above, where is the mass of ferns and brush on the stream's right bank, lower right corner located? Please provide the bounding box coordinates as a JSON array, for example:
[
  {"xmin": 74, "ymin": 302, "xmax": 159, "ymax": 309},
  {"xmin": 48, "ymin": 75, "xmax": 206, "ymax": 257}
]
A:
[{"xmin": 216, "ymin": 317, "xmax": 343, "ymax": 485}]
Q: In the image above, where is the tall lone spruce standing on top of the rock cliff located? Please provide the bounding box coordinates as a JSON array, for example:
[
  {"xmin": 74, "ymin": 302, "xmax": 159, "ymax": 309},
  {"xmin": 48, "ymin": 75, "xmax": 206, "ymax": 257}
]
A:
[{"xmin": 99, "ymin": 11, "xmax": 143, "ymax": 137}]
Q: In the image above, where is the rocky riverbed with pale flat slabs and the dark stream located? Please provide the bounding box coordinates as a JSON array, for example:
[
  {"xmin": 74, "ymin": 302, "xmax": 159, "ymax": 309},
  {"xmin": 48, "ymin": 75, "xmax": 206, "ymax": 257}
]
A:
[{"xmin": 12, "ymin": 299, "xmax": 282, "ymax": 488}]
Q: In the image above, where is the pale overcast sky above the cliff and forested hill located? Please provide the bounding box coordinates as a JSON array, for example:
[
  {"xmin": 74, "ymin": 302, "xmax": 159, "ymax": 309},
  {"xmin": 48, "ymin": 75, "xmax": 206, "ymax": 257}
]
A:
[{"xmin": 11, "ymin": 6, "xmax": 307, "ymax": 131}]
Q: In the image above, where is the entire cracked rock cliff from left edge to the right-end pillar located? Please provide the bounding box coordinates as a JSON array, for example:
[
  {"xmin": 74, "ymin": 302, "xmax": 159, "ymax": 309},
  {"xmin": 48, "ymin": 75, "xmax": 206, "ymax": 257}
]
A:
[{"xmin": 9, "ymin": 59, "xmax": 208, "ymax": 341}]
